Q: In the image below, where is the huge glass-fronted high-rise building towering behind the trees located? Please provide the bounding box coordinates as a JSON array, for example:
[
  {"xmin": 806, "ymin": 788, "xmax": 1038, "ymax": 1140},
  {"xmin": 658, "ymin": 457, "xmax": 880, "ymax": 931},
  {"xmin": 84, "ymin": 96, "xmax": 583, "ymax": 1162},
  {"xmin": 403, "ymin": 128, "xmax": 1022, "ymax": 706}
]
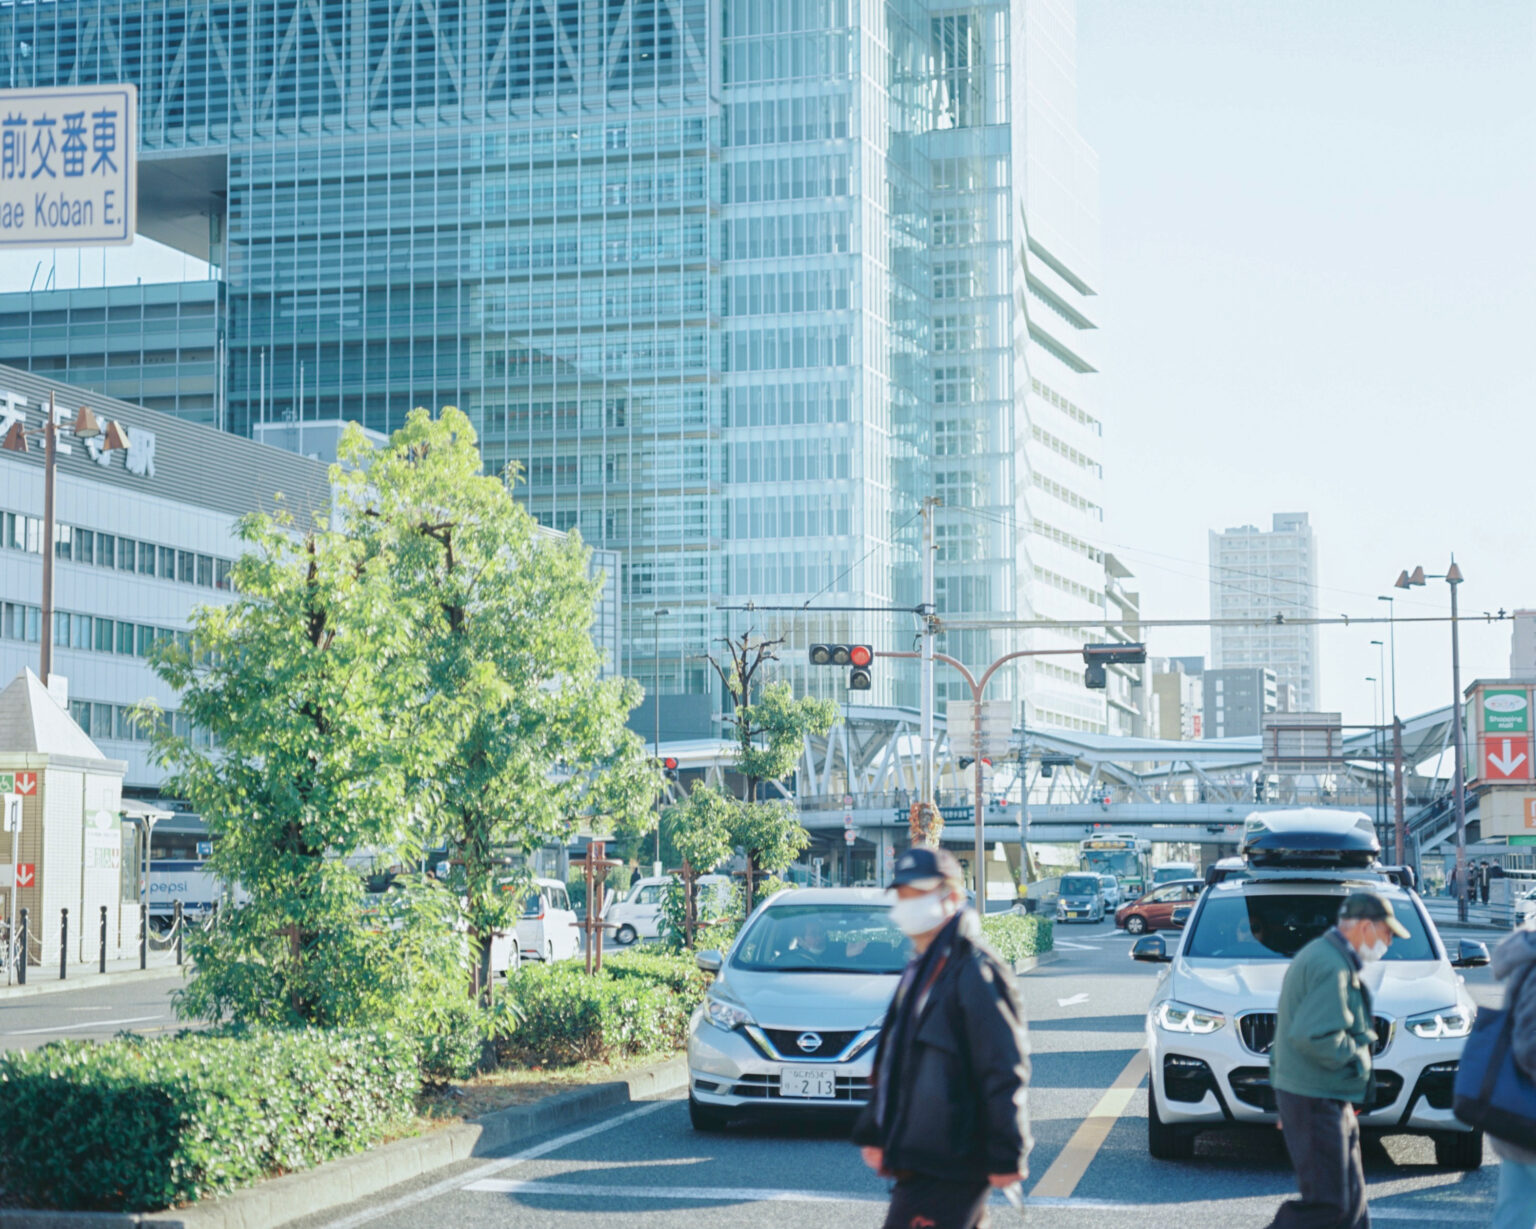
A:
[{"xmin": 0, "ymin": 0, "xmax": 1106, "ymax": 728}]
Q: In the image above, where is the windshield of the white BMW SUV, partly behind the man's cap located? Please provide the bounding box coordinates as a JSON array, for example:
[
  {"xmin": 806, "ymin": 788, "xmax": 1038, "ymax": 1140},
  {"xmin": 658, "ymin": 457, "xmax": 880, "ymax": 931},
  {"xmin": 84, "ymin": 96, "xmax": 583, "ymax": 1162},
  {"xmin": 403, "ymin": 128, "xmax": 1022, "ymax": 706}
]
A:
[{"xmin": 1184, "ymin": 893, "xmax": 1435, "ymax": 960}]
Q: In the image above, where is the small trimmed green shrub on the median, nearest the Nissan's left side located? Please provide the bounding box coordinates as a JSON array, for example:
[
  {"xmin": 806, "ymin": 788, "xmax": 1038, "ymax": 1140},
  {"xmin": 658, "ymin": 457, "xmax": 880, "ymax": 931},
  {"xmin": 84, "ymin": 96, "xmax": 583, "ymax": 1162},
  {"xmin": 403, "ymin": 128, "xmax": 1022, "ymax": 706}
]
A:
[{"xmin": 496, "ymin": 965, "xmax": 688, "ymax": 1066}]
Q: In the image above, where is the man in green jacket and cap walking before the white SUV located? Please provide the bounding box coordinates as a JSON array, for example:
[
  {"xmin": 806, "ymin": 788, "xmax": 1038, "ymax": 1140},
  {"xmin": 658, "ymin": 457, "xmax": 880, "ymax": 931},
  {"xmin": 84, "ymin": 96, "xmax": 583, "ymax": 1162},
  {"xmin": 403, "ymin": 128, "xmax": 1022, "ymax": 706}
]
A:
[{"xmin": 1269, "ymin": 891, "xmax": 1409, "ymax": 1229}]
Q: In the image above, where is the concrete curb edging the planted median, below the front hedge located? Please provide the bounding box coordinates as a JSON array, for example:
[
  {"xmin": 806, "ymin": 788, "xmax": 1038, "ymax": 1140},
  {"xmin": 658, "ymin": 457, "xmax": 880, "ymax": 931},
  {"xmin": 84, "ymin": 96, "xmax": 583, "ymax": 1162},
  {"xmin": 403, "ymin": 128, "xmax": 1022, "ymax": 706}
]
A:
[{"xmin": 0, "ymin": 1055, "xmax": 688, "ymax": 1229}]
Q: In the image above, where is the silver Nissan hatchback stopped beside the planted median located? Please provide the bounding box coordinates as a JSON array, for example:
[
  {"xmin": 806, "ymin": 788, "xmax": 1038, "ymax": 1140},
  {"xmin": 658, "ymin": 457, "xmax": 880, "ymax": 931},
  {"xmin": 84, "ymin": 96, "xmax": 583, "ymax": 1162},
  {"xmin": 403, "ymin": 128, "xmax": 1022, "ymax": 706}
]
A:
[{"xmin": 688, "ymin": 888, "xmax": 909, "ymax": 1131}]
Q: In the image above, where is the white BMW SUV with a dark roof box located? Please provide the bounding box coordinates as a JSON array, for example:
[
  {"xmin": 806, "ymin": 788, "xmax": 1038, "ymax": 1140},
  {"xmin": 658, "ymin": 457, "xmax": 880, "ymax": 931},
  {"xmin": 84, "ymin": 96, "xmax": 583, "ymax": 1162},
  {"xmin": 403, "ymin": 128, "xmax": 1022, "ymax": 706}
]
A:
[{"xmin": 1132, "ymin": 811, "xmax": 1488, "ymax": 1169}]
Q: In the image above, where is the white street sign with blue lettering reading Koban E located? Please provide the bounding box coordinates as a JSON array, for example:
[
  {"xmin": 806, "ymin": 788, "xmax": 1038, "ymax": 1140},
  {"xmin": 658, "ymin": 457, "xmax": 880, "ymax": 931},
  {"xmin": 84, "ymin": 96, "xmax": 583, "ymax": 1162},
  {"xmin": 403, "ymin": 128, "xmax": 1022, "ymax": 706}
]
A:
[{"xmin": 0, "ymin": 84, "xmax": 138, "ymax": 249}]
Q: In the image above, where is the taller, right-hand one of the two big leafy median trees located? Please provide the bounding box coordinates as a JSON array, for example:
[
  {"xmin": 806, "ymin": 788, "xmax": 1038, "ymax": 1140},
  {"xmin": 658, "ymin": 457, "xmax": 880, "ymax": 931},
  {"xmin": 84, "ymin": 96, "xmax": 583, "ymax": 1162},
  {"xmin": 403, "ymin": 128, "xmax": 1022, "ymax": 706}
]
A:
[{"xmin": 339, "ymin": 407, "xmax": 656, "ymax": 992}]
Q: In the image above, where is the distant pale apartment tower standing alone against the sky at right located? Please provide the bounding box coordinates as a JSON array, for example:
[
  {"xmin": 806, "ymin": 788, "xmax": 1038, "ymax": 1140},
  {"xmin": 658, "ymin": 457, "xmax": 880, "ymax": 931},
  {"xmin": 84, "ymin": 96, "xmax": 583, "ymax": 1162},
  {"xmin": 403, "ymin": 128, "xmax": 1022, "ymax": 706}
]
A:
[{"xmin": 1206, "ymin": 512, "xmax": 1318, "ymax": 709}]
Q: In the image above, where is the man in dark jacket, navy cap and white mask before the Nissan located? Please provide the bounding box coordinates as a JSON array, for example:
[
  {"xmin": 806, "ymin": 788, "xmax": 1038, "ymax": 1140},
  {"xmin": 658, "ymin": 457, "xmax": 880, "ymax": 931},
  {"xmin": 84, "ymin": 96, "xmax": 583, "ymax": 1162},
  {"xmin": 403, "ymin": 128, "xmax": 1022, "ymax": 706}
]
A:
[{"xmin": 854, "ymin": 848, "xmax": 1031, "ymax": 1229}]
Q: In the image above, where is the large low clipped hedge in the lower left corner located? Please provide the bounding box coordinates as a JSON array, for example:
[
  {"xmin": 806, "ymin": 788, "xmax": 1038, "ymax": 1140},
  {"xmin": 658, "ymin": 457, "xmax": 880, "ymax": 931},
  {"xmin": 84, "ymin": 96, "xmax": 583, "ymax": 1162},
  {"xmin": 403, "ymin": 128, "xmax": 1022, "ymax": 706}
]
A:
[{"xmin": 0, "ymin": 1029, "xmax": 419, "ymax": 1212}]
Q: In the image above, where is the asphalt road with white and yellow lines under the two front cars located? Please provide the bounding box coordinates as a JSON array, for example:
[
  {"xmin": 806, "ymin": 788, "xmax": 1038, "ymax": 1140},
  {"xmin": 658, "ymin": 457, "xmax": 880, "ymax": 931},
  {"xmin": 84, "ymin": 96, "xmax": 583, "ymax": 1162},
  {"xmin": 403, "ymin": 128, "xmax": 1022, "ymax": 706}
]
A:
[{"xmin": 298, "ymin": 926, "xmax": 1498, "ymax": 1229}]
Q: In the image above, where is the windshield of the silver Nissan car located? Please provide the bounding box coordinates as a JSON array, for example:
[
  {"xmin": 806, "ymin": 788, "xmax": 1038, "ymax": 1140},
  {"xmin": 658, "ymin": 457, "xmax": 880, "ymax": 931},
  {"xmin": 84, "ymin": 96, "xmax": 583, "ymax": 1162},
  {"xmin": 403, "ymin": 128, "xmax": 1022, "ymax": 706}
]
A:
[{"xmin": 731, "ymin": 905, "xmax": 908, "ymax": 972}]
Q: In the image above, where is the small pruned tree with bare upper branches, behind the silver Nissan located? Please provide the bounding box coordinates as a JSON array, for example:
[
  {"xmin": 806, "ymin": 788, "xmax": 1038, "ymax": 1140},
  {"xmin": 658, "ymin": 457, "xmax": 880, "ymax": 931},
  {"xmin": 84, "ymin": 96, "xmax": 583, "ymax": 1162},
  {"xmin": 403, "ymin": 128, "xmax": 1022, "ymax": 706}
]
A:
[{"xmin": 710, "ymin": 633, "xmax": 837, "ymax": 913}]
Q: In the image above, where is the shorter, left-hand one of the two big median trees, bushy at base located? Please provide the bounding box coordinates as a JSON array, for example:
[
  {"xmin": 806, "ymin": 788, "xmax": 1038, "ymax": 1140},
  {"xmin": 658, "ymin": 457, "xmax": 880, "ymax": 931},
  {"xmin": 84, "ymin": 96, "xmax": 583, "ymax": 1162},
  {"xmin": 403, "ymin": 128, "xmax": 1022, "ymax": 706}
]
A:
[{"xmin": 152, "ymin": 515, "xmax": 465, "ymax": 1025}]
